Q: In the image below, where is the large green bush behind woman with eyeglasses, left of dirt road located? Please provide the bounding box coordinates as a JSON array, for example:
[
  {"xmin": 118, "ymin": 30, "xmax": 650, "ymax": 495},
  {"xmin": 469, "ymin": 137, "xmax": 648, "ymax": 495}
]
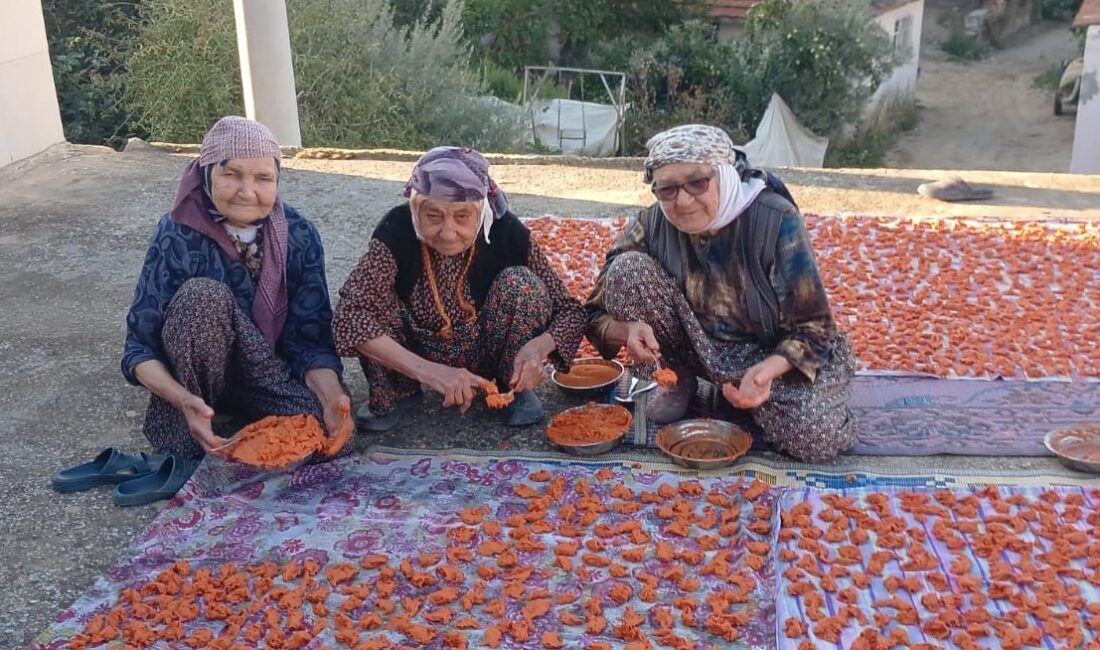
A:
[{"xmin": 593, "ymin": 0, "xmax": 897, "ymax": 153}]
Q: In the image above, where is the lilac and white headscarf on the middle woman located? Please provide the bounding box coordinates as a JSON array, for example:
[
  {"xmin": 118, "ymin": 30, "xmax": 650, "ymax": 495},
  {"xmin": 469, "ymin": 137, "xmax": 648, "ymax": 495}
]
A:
[{"xmin": 405, "ymin": 146, "xmax": 508, "ymax": 242}]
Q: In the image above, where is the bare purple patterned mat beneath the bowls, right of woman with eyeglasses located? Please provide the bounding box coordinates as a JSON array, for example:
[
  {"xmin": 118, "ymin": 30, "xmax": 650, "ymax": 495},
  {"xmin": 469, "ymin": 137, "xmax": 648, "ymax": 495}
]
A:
[{"xmin": 605, "ymin": 376, "xmax": 1100, "ymax": 456}]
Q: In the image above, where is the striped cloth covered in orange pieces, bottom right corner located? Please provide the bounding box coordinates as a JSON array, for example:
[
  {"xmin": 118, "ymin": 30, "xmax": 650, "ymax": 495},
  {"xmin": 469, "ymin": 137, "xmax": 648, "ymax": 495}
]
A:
[{"xmin": 776, "ymin": 487, "xmax": 1100, "ymax": 650}]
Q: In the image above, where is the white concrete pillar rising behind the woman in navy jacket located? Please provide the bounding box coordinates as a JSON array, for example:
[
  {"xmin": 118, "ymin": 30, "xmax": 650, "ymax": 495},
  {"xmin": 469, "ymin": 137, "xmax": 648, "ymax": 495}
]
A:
[{"xmin": 233, "ymin": 0, "xmax": 301, "ymax": 146}]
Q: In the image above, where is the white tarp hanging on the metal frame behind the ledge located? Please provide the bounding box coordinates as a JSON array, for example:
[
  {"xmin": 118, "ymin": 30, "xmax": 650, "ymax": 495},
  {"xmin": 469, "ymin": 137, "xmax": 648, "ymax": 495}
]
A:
[{"xmin": 531, "ymin": 99, "xmax": 618, "ymax": 156}]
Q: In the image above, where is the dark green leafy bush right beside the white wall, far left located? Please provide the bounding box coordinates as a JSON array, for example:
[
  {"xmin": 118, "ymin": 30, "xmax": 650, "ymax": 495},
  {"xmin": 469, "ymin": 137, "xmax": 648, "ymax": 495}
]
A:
[{"xmin": 42, "ymin": 0, "xmax": 145, "ymax": 145}]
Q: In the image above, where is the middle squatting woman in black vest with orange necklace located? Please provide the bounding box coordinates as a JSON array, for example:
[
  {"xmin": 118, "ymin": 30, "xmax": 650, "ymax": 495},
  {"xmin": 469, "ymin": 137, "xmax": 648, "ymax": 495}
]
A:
[{"xmin": 332, "ymin": 147, "xmax": 584, "ymax": 431}]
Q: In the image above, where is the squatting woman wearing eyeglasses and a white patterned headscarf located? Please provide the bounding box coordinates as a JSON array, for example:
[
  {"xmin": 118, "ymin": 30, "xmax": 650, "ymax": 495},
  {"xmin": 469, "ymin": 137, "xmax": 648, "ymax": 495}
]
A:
[{"xmin": 585, "ymin": 124, "xmax": 855, "ymax": 461}]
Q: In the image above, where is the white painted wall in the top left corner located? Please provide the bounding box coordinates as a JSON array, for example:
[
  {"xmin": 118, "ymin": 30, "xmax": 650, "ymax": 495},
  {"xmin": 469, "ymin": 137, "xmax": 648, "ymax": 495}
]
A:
[{"xmin": 0, "ymin": 0, "xmax": 65, "ymax": 167}]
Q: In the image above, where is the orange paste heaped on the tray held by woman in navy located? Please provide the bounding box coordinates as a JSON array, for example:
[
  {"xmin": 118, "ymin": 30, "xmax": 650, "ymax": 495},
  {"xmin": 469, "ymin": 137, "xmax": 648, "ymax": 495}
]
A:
[{"xmin": 229, "ymin": 415, "xmax": 327, "ymax": 470}]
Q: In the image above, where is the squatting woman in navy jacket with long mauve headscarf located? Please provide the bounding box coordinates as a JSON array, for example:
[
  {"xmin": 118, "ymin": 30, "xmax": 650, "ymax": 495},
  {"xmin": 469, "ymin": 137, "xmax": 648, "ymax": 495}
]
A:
[{"xmin": 122, "ymin": 117, "xmax": 349, "ymax": 475}]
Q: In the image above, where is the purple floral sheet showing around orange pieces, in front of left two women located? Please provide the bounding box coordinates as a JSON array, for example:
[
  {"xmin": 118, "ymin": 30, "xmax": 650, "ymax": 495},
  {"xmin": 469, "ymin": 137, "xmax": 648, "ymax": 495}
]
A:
[{"xmin": 30, "ymin": 455, "xmax": 780, "ymax": 650}]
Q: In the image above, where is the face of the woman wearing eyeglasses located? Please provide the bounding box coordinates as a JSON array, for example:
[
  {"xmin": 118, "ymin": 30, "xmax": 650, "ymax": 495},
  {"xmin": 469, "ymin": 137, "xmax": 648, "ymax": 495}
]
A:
[{"xmin": 653, "ymin": 163, "xmax": 718, "ymax": 234}]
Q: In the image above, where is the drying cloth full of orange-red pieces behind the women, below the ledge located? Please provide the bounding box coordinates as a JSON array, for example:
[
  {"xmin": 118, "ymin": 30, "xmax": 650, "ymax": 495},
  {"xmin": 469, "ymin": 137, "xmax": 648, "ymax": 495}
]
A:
[{"xmin": 527, "ymin": 214, "xmax": 1100, "ymax": 381}]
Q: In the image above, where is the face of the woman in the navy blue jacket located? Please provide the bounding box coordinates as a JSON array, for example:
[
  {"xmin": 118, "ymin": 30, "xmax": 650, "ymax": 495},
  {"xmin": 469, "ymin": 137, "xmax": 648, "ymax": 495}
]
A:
[{"xmin": 210, "ymin": 157, "xmax": 278, "ymax": 227}]
